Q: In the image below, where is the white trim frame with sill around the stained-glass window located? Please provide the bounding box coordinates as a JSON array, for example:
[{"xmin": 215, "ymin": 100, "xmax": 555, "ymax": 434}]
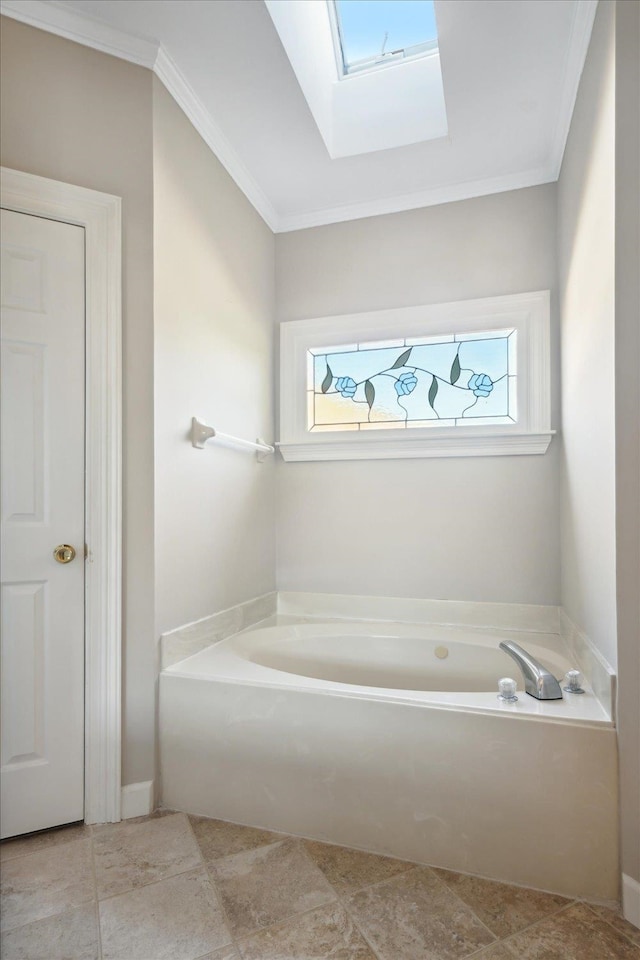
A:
[{"xmin": 278, "ymin": 290, "xmax": 555, "ymax": 461}]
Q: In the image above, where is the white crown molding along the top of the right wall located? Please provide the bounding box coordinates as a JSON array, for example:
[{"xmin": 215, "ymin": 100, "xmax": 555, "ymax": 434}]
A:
[{"xmin": 549, "ymin": 0, "xmax": 598, "ymax": 180}]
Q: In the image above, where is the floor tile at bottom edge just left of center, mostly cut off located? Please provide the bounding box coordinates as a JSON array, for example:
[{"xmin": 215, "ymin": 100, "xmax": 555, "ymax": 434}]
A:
[{"xmin": 238, "ymin": 904, "xmax": 376, "ymax": 960}]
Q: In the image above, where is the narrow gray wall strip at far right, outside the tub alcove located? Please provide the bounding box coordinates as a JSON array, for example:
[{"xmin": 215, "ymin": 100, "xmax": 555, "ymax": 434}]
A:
[{"xmin": 615, "ymin": 3, "xmax": 640, "ymax": 882}]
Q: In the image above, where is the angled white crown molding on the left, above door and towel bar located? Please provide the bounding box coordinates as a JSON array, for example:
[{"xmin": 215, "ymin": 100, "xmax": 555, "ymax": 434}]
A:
[{"xmin": 0, "ymin": 0, "xmax": 278, "ymax": 233}]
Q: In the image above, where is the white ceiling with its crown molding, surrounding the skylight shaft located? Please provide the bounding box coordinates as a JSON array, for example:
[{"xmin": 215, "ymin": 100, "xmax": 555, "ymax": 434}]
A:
[{"xmin": 0, "ymin": 0, "xmax": 597, "ymax": 232}]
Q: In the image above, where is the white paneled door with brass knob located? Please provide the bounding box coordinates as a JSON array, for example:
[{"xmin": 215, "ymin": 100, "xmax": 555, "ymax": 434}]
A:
[{"xmin": 0, "ymin": 210, "xmax": 85, "ymax": 837}]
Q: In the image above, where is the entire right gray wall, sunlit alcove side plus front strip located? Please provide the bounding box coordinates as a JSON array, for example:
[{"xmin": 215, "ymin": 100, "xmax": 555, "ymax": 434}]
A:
[{"xmin": 558, "ymin": 0, "xmax": 640, "ymax": 881}]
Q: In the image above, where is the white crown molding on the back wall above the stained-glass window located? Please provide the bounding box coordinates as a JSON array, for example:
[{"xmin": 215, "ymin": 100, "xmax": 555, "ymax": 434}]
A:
[{"xmin": 276, "ymin": 166, "xmax": 558, "ymax": 233}]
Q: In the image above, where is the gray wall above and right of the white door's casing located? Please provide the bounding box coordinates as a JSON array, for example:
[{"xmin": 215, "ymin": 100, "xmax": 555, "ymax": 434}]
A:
[{"xmin": 1, "ymin": 18, "xmax": 156, "ymax": 783}]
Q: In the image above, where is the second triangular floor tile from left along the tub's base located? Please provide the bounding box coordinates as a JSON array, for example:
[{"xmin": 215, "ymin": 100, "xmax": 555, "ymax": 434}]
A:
[{"xmin": 304, "ymin": 840, "xmax": 415, "ymax": 894}]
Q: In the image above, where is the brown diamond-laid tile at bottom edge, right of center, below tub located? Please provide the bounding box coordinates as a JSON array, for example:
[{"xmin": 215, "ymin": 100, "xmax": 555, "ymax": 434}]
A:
[{"xmin": 345, "ymin": 867, "xmax": 494, "ymax": 960}]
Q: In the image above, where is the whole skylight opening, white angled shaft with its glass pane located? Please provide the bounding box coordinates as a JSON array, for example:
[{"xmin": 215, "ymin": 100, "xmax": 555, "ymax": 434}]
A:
[{"xmin": 264, "ymin": 0, "xmax": 448, "ymax": 160}]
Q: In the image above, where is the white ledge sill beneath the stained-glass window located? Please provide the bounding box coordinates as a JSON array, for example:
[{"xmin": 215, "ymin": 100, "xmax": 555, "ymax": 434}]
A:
[{"xmin": 276, "ymin": 430, "xmax": 555, "ymax": 461}]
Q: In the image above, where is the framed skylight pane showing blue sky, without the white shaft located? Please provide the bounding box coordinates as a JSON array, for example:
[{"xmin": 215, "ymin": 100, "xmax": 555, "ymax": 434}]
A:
[{"xmin": 328, "ymin": 0, "xmax": 438, "ymax": 76}]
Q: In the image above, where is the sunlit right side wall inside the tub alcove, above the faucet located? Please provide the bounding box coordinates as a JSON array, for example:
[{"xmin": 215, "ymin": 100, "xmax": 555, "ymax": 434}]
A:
[{"xmin": 558, "ymin": 0, "xmax": 616, "ymax": 666}]
